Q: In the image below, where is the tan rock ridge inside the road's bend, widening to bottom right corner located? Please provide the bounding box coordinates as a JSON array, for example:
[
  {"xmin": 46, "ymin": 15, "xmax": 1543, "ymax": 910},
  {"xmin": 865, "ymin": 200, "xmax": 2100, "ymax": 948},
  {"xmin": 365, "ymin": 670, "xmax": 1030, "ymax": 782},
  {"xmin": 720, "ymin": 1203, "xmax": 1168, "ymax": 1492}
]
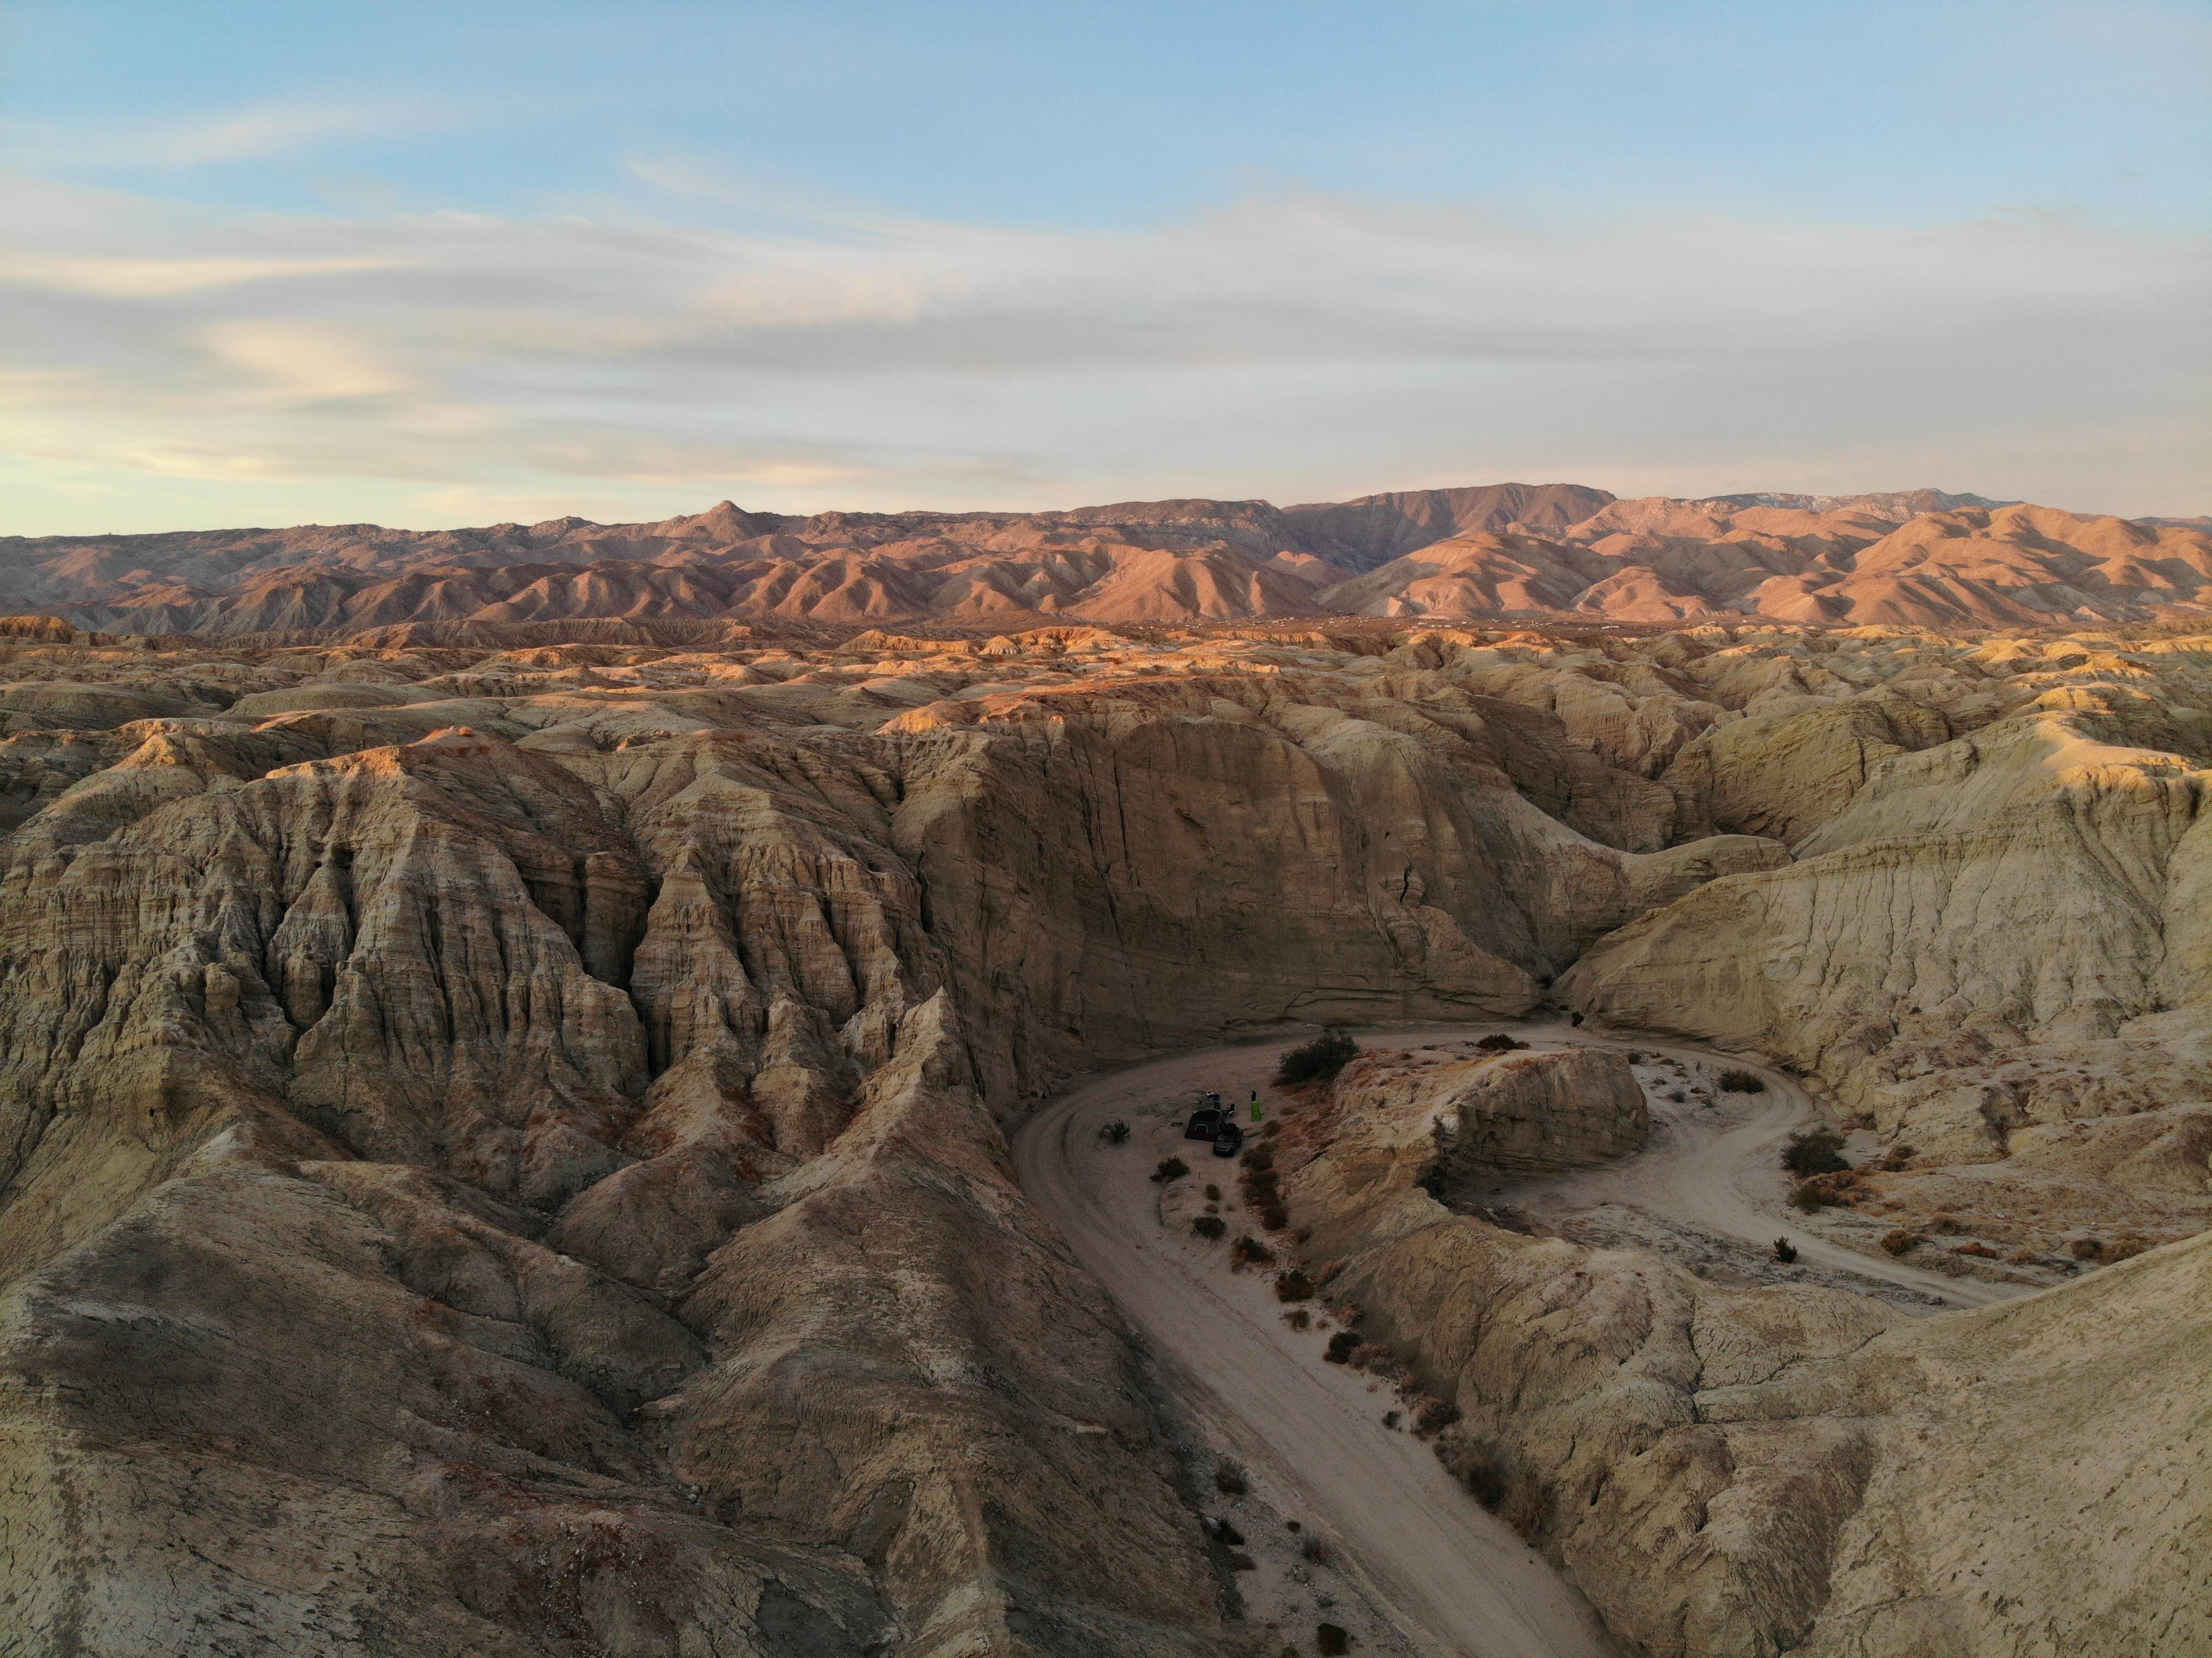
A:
[{"xmin": 1274, "ymin": 1054, "xmax": 2212, "ymax": 1658}]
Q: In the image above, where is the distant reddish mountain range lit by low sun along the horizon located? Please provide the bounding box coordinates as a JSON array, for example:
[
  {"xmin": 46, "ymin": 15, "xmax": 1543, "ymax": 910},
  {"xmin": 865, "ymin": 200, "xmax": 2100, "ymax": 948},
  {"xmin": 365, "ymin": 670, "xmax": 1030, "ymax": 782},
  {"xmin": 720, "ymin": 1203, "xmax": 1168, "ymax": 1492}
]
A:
[{"xmin": 0, "ymin": 484, "xmax": 2212, "ymax": 636}]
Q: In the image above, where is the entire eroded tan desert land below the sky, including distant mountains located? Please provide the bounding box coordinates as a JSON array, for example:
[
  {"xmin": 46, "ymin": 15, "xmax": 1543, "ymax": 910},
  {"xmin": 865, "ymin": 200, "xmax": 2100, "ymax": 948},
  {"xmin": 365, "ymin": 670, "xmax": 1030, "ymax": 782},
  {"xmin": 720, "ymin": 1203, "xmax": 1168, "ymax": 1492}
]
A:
[{"xmin": 0, "ymin": 486, "xmax": 2212, "ymax": 1658}]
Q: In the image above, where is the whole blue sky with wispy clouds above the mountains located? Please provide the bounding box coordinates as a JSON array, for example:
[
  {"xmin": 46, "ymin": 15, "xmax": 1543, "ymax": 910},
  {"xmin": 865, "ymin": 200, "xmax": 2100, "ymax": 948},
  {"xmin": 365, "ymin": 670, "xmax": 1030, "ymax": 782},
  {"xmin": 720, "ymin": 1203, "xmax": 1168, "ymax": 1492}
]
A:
[{"xmin": 0, "ymin": 0, "xmax": 2212, "ymax": 535}]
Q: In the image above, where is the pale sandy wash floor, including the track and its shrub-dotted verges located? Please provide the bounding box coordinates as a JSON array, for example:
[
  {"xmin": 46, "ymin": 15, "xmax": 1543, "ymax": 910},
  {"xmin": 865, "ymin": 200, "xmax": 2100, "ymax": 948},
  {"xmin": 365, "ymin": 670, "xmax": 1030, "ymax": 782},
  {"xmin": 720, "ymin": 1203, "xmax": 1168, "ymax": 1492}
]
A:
[{"xmin": 1013, "ymin": 1022, "xmax": 2017, "ymax": 1658}]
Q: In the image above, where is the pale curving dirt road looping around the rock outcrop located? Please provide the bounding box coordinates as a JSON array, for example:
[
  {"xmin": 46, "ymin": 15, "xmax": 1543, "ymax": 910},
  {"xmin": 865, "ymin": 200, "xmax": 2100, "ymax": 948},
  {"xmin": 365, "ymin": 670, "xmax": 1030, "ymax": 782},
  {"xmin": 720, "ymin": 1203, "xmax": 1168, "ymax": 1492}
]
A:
[{"xmin": 1013, "ymin": 1019, "xmax": 2013, "ymax": 1658}]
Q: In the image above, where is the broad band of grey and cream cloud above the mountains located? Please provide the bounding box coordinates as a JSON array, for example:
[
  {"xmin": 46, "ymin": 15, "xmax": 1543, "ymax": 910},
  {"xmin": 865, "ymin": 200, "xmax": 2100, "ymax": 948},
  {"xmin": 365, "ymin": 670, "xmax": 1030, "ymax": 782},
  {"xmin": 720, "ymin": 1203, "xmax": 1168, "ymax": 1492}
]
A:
[{"xmin": 0, "ymin": 175, "xmax": 2212, "ymax": 528}]
